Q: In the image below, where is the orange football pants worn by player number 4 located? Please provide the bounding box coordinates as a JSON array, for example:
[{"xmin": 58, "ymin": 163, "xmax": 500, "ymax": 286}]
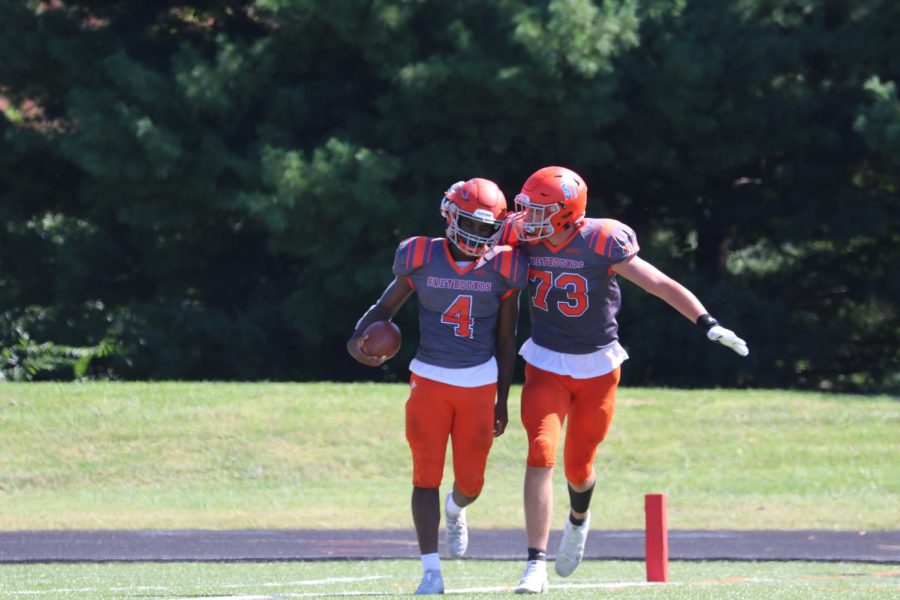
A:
[{"xmin": 406, "ymin": 374, "xmax": 497, "ymax": 497}]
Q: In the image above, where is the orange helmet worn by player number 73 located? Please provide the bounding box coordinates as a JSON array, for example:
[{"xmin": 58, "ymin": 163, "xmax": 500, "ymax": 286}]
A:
[{"xmin": 515, "ymin": 167, "xmax": 587, "ymax": 242}]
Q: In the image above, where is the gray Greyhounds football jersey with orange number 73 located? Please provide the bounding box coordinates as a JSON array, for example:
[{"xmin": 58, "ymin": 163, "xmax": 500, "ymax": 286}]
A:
[{"xmin": 519, "ymin": 219, "xmax": 639, "ymax": 354}]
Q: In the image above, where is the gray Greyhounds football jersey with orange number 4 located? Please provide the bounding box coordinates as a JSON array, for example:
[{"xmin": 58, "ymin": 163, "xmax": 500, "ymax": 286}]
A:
[{"xmin": 393, "ymin": 237, "xmax": 528, "ymax": 369}]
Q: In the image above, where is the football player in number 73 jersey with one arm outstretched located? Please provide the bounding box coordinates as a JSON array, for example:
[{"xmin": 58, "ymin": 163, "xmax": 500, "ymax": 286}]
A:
[{"xmin": 501, "ymin": 167, "xmax": 748, "ymax": 593}]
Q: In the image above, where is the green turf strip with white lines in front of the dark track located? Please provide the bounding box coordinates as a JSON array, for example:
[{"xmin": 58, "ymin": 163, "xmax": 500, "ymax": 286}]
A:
[{"xmin": 0, "ymin": 561, "xmax": 900, "ymax": 600}]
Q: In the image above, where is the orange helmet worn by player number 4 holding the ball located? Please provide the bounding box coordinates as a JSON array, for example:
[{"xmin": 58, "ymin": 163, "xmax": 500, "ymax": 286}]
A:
[{"xmin": 441, "ymin": 177, "xmax": 507, "ymax": 257}]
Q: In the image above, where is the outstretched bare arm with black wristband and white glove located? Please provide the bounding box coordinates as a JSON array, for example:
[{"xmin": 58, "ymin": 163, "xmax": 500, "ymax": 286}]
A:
[{"xmin": 610, "ymin": 256, "xmax": 750, "ymax": 356}]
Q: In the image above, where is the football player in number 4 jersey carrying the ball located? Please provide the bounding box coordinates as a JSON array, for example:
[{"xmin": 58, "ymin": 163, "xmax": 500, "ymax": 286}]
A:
[{"xmin": 347, "ymin": 178, "xmax": 528, "ymax": 594}]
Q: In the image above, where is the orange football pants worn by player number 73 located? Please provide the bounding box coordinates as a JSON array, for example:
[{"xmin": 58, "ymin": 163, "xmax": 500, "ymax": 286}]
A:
[{"xmin": 522, "ymin": 363, "xmax": 621, "ymax": 484}]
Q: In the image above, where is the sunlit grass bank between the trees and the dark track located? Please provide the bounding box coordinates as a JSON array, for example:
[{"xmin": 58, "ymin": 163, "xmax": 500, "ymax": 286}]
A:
[{"xmin": 0, "ymin": 383, "xmax": 900, "ymax": 530}]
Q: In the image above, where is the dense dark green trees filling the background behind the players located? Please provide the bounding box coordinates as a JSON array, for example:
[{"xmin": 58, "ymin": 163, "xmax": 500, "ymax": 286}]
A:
[{"xmin": 0, "ymin": 0, "xmax": 900, "ymax": 392}]
